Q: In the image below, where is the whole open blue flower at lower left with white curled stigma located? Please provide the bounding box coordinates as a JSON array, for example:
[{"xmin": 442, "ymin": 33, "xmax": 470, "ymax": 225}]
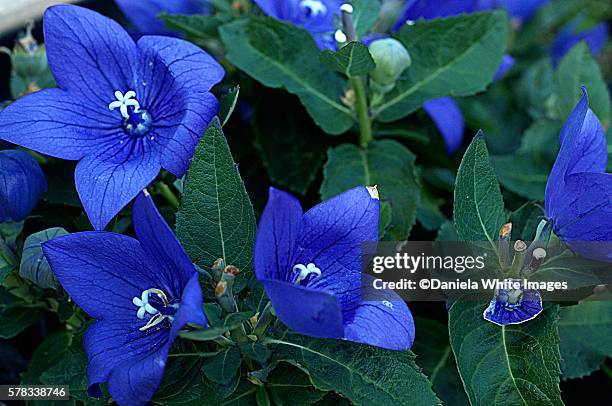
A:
[{"xmin": 43, "ymin": 192, "xmax": 207, "ymax": 405}]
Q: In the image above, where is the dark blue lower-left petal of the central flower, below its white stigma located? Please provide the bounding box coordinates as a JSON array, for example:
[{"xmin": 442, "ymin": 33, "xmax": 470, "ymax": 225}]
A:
[{"xmin": 260, "ymin": 279, "xmax": 344, "ymax": 338}]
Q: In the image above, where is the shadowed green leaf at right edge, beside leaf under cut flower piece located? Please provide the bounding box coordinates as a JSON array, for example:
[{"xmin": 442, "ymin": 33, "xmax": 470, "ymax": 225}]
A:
[{"xmin": 559, "ymin": 301, "xmax": 612, "ymax": 379}]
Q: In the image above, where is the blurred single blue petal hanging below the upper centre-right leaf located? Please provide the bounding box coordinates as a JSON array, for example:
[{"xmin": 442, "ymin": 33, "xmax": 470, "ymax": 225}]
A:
[{"xmin": 423, "ymin": 97, "xmax": 465, "ymax": 154}]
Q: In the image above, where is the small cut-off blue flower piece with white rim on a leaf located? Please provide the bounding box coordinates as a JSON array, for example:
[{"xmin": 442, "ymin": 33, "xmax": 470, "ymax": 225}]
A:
[{"xmin": 483, "ymin": 279, "xmax": 542, "ymax": 326}]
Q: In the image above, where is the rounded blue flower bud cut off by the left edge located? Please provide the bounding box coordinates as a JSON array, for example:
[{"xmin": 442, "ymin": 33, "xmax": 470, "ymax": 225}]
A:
[{"xmin": 0, "ymin": 150, "xmax": 47, "ymax": 223}]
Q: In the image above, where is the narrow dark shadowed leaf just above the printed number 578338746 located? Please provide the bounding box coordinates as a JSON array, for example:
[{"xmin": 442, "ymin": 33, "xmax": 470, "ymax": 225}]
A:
[{"xmin": 21, "ymin": 330, "xmax": 72, "ymax": 385}]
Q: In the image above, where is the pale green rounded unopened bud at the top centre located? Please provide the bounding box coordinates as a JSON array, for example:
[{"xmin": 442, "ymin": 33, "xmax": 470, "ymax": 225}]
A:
[{"xmin": 370, "ymin": 38, "xmax": 412, "ymax": 86}]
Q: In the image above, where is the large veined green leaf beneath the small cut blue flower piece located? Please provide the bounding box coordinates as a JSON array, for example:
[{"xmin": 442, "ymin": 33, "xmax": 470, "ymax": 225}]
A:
[{"xmin": 448, "ymin": 302, "xmax": 563, "ymax": 406}]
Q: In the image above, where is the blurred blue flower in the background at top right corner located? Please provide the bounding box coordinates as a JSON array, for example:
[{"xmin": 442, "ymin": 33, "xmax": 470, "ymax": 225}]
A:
[{"xmin": 550, "ymin": 21, "xmax": 608, "ymax": 62}]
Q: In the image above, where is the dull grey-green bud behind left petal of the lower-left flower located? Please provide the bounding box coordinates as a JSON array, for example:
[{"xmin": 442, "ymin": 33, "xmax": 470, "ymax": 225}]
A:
[{"xmin": 19, "ymin": 227, "xmax": 68, "ymax": 290}]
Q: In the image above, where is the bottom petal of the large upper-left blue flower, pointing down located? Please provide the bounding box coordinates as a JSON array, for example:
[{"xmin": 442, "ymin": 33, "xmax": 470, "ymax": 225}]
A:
[{"xmin": 75, "ymin": 139, "xmax": 161, "ymax": 230}]
